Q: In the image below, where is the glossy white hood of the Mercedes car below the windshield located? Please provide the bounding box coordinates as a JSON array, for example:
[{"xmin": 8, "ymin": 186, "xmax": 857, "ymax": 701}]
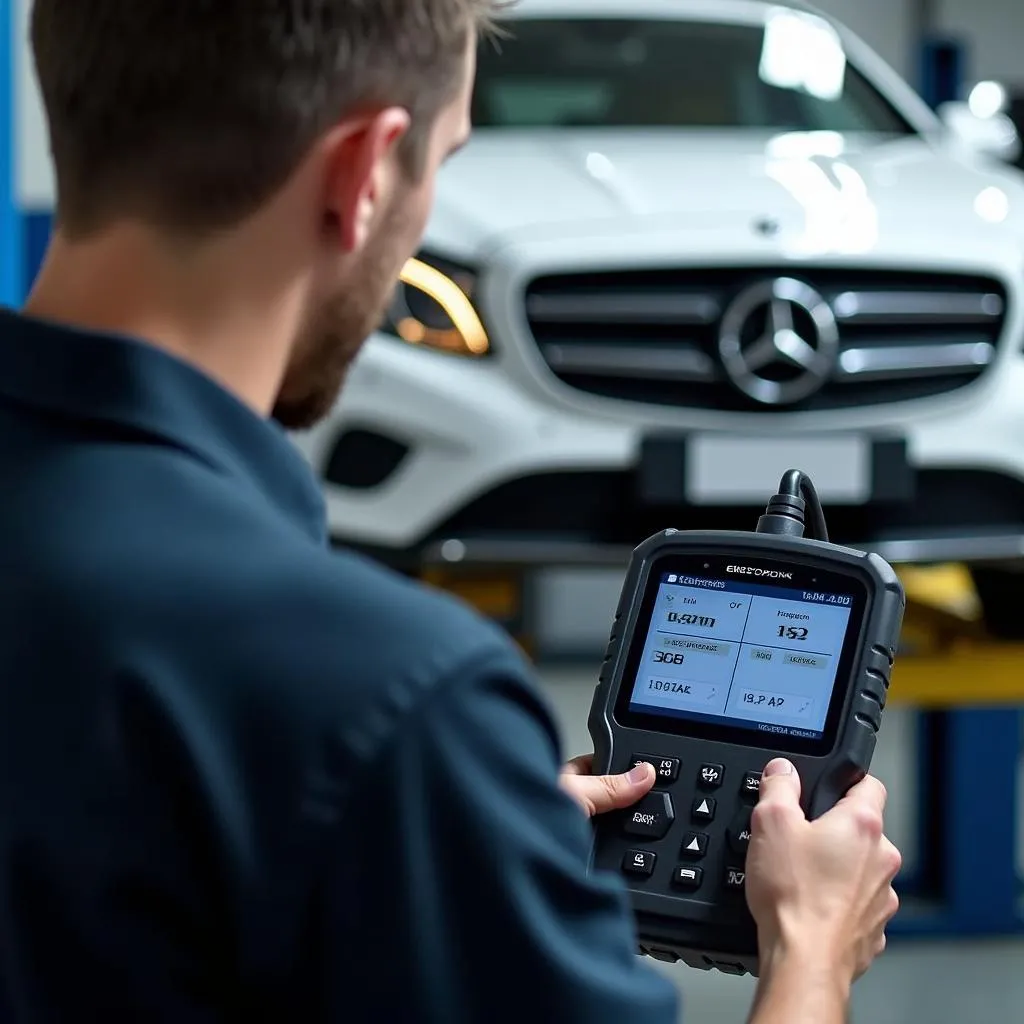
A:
[{"xmin": 427, "ymin": 130, "xmax": 1024, "ymax": 257}]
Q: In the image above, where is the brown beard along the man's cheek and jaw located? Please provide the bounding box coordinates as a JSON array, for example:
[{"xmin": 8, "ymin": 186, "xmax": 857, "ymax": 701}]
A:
[{"xmin": 273, "ymin": 197, "xmax": 409, "ymax": 430}]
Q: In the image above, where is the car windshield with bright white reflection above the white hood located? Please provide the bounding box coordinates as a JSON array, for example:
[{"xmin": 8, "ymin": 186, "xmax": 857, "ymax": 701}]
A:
[{"xmin": 473, "ymin": 11, "xmax": 913, "ymax": 134}]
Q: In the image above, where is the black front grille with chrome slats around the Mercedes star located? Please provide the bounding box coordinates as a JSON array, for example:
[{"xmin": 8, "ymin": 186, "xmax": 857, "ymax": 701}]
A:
[{"xmin": 525, "ymin": 266, "xmax": 1007, "ymax": 412}]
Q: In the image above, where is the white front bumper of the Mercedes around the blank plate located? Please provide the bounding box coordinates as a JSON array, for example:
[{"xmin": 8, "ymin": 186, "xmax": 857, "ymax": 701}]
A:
[{"xmin": 299, "ymin": 338, "xmax": 1024, "ymax": 564}]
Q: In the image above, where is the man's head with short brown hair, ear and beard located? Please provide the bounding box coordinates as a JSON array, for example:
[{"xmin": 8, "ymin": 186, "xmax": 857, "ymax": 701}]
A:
[{"xmin": 32, "ymin": 0, "xmax": 501, "ymax": 427}]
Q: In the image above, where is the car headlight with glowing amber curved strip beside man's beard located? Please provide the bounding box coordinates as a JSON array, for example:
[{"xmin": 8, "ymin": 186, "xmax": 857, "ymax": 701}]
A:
[{"xmin": 382, "ymin": 255, "xmax": 490, "ymax": 356}]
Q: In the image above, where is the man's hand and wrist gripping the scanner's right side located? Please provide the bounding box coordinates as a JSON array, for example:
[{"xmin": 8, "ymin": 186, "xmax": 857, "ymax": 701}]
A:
[{"xmin": 746, "ymin": 761, "xmax": 900, "ymax": 1024}]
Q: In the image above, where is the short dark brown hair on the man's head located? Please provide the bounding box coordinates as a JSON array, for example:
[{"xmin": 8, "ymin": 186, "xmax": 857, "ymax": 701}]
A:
[{"xmin": 32, "ymin": 0, "xmax": 502, "ymax": 236}]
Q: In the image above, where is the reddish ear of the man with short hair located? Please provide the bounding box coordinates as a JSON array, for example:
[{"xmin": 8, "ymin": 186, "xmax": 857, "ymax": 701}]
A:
[{"xmin": 326, "ymin": 106, "xmax": 411, "ymax": 252}]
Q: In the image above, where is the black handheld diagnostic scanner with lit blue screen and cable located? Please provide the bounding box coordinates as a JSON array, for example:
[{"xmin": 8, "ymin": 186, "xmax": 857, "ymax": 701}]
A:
[{"xmin": 590, "ymin": 470, "xmax": 905, "ymax": 975}]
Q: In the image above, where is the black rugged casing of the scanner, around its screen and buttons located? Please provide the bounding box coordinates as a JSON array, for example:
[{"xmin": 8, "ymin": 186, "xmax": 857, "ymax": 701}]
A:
[{"xmin": 589, "ymin": 530, "xmax": 905, "ymax": 976}]
